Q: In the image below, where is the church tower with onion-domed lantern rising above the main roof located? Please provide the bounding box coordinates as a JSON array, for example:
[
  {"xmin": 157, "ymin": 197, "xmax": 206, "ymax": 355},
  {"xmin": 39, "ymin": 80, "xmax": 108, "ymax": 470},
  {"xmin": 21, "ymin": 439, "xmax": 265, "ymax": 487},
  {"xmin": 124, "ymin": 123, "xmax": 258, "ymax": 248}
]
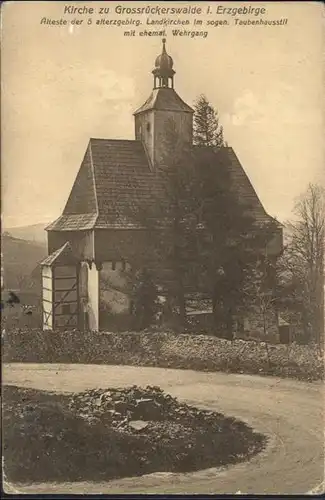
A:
[{"xmin": 134, "ymin": 38, "xmax": 194, "ymax": 169}]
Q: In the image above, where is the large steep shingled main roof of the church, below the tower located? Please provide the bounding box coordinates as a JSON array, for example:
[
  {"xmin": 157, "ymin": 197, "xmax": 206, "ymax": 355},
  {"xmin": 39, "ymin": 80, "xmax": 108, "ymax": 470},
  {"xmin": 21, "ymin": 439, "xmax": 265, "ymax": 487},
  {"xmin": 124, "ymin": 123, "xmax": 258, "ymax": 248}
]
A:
[{"xmin": 47, "ymin": 139, "xmax": 270, "ymax": 231}]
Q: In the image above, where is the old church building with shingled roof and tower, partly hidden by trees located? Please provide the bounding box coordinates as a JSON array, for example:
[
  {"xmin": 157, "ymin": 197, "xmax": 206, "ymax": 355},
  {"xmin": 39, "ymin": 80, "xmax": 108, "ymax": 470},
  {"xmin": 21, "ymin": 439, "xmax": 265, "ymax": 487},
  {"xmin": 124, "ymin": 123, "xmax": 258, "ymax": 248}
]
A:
[{"xmin": 42, "ymin": 40, "xmax": 282, "ymax": 331}]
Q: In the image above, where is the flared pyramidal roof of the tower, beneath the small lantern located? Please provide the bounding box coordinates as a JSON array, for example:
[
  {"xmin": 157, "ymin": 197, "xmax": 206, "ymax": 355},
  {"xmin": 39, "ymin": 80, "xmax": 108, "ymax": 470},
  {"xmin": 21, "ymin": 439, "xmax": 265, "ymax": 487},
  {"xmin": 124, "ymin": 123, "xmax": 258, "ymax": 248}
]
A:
[{"xmin": 134, "ymin": 87, "xmax": 194, "ymax": 115}]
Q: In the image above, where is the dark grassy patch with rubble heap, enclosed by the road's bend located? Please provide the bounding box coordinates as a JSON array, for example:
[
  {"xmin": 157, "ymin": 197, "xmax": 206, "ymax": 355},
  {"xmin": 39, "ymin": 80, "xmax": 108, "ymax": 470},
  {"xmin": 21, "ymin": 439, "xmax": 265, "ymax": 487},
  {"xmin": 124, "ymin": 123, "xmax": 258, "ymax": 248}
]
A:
[{"xmin": 3, "ymin": 386, "xmax": 266, "ymax": 482}]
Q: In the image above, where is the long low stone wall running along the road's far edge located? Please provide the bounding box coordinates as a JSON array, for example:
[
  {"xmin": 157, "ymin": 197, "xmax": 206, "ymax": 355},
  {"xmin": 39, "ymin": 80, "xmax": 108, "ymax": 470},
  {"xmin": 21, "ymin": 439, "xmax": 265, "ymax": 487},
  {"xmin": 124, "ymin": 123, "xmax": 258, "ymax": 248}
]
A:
[{"xmin": 3, "ymin": 330, "xmax": 324, "ymax": 381}]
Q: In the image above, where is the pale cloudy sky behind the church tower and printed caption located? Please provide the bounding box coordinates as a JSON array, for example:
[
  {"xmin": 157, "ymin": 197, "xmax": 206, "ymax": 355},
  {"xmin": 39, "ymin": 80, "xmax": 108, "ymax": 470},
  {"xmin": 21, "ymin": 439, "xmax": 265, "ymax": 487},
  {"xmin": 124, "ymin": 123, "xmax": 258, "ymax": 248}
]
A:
[{"xmin": 1, "ymin": 1, "xmax": 325, "ymax": 227}]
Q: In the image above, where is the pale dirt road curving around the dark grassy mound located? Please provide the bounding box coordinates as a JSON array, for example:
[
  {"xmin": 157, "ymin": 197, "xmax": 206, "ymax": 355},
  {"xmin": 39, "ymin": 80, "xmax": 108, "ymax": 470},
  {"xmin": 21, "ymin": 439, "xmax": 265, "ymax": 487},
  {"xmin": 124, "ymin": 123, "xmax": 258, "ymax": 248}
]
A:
[{"xmin": 3, "ymin": 363, "xmax": 325, "ymax": 494}]
